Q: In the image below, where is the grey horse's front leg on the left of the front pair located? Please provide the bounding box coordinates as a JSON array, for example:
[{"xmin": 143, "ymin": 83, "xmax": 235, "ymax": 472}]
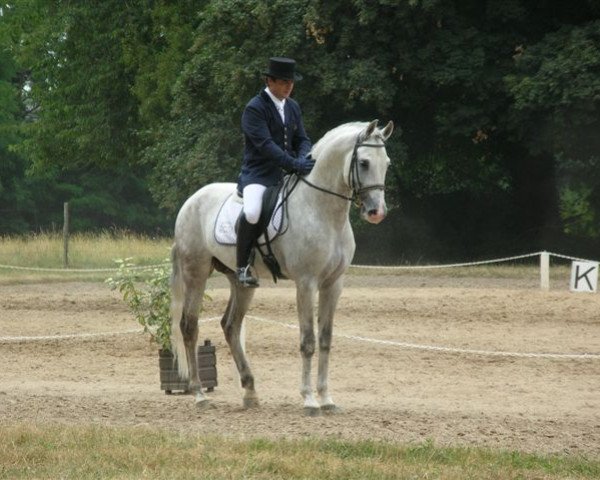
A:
[{"xmin": 296, "ymin": 282, "xmax": 320, "ymax": 416}]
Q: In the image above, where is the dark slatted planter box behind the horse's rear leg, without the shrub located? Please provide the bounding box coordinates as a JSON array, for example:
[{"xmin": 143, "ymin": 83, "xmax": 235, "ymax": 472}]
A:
[{"xmin": 158, "ymin": 340, "xmax": 217, "ymax": 395}]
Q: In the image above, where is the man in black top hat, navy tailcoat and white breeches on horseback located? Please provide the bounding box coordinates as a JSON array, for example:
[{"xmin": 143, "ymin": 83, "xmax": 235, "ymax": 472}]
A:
[{"xmin": 237, "ymin": 57, "xmax": 315, "ymax": 287}]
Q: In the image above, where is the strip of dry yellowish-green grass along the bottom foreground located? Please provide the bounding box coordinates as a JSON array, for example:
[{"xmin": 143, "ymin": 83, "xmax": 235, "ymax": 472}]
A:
[{"xmin": 0, "ymin": 425, "xmax": 600, "ymax": 480}]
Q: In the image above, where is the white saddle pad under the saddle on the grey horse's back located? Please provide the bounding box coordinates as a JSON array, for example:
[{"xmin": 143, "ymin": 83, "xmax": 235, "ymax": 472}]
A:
[{"xmin": 215, "ymin": 192, "xmax": 286, "ymax": 245}]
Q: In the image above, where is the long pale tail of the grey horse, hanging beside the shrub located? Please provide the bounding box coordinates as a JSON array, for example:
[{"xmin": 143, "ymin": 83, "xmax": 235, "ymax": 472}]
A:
[{"xmin": 171, "ymin": 244, "xmax": 190, "ymax": 379}]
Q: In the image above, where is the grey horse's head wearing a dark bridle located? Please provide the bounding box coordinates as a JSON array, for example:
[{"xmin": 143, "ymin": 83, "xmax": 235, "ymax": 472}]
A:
[{"xmin": 347, "ymin": 120, "xmax": 394, "ymax": 223}]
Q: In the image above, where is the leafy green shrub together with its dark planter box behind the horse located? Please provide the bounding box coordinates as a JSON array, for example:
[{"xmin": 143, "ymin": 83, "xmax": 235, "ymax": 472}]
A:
[{"xmin": 106, "ymin": 258, "xmax": 217, "ymax": 394}]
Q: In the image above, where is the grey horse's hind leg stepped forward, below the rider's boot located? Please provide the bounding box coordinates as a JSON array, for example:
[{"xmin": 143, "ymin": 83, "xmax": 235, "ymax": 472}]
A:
[{"xmin": 221, "ymin": 274, "xmax": 258, "ymax": 408}]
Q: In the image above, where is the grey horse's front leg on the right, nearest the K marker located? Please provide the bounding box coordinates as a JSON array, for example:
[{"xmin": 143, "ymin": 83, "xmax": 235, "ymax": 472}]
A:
[{"xmin": 317, "ymin": 278, "xmax": 342, "ymax": 413}]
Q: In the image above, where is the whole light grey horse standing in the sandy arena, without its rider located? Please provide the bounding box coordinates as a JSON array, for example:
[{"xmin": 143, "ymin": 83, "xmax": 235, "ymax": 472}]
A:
[{"xmin": 171, "ymin": 120, "xmax": 394, "ymax": 415}]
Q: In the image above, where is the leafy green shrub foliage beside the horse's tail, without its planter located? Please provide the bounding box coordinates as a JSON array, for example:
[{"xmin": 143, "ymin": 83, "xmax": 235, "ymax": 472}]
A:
[{"xmin": 106, "ymin": 258, "xmax": 171, "ymax": 351}]
